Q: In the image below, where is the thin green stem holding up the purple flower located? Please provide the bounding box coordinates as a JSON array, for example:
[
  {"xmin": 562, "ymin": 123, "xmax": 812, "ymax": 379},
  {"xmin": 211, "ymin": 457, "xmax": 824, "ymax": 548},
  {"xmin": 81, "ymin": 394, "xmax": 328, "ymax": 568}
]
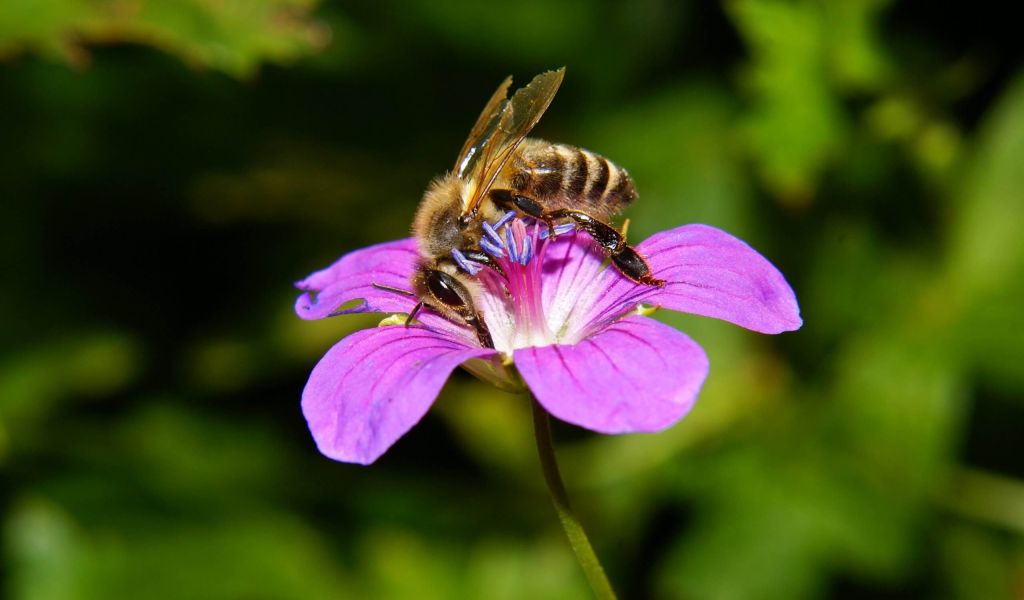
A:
[{"xmin": 530, "ymin": 397, "xmax": 615, "ymax": 600}]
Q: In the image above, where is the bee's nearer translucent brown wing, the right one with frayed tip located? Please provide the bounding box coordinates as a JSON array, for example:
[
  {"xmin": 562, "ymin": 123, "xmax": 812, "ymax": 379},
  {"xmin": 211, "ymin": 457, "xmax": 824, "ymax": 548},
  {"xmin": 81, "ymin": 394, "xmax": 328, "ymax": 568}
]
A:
[{"xmin": 463, "ymin": 67, "xmax": 565, "ymax": 214}]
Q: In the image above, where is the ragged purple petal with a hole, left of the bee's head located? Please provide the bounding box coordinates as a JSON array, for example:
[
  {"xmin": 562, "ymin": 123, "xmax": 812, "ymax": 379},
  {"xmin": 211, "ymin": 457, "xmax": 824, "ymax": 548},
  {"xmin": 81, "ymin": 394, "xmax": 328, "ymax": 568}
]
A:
[{"xmin": 295, "ymin": 238, "xmax": 418, "ymax": 319}]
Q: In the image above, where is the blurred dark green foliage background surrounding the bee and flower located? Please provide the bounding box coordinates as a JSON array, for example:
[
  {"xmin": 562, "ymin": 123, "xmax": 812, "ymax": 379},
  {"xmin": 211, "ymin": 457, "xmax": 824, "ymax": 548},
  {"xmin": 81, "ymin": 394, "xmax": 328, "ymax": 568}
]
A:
[{"xmin": 0, "ymin": 0, "xmax": 1024, "ymax": 600}]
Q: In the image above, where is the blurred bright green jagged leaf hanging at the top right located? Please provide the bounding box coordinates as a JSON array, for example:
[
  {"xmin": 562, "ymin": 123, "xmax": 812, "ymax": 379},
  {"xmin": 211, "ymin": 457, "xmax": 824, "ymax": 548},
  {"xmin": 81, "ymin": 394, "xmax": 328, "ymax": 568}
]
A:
[{"xmin": 728, "ymin": 0, "xmax": 888, "ymax": 204}]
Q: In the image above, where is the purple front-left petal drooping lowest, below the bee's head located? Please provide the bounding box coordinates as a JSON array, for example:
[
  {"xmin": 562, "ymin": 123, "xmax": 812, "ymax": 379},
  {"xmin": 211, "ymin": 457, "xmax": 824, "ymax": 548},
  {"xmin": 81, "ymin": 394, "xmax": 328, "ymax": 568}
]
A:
[{"xmin": 302, "ymin": 326, "xmax": 495, "ymax": 465}]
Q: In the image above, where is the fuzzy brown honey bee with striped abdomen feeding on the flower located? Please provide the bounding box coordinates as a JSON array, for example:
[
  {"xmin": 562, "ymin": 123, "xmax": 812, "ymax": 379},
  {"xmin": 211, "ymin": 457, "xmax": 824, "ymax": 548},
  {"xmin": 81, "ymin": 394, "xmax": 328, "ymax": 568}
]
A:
[{"xmin": 409, "ymin": 68, "xmax": 665, "ymax": 347}]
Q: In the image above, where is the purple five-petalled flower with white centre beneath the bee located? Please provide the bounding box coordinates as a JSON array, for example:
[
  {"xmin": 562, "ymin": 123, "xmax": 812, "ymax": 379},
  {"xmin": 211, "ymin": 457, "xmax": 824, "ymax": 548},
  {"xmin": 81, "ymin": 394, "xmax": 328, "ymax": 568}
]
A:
[{"xmin": 295, "ymin": 219, "xmax": 802, "ymax": 464}]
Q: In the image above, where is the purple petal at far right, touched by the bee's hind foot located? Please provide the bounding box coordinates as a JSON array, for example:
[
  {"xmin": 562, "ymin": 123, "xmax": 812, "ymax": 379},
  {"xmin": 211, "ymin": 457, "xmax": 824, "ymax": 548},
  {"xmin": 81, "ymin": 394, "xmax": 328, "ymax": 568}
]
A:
[{"xmin": 638, "ymin": 225, "xmax": 803, "ymax": 334}]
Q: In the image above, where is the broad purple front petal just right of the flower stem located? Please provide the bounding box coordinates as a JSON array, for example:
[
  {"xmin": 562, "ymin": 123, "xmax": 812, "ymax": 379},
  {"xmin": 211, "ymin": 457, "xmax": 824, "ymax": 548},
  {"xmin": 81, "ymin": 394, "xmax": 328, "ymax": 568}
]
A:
[{"xmin": 515, "ymin": 316, "xmax": 708, "ymax": 433}]
